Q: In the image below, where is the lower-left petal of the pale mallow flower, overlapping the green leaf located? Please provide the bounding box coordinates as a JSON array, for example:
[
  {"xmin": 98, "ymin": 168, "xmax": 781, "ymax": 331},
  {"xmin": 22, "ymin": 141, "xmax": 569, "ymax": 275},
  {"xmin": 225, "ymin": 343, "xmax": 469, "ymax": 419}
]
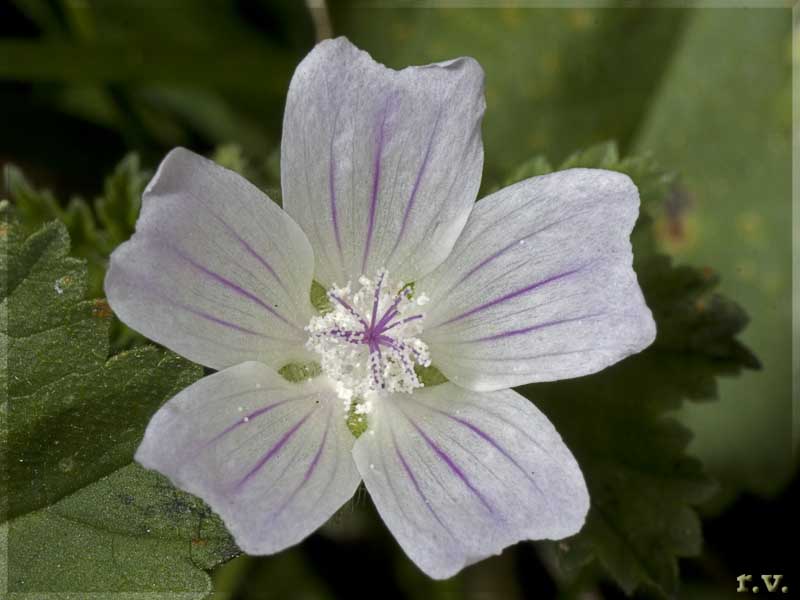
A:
[{"xmin": 136, "ymin": 362, "xmax": 360, "ymax": 554}]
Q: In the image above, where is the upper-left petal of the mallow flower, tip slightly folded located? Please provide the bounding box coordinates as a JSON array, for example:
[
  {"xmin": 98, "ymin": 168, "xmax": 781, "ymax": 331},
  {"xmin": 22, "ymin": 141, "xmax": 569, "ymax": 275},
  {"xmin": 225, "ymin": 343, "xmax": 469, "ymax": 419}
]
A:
[{"xmin": 105, "ymin": 148, "xmax": 314, "ymax": 369}]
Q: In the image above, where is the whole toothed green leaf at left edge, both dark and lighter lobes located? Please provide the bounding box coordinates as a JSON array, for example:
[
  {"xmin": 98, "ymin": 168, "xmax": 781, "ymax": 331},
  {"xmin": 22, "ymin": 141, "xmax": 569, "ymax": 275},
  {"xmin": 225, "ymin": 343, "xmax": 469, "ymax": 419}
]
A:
[{"xmin": 0, "ymin": 210, "xmax": 237, "ymax": 598}]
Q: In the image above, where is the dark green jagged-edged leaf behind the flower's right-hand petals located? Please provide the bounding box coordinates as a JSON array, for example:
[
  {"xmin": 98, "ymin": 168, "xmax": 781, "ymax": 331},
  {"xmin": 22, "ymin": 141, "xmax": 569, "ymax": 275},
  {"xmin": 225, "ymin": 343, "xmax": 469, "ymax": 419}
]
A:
[{"xmin": 520, "ymin": 143, "xmax": 759, "ymax": 595}]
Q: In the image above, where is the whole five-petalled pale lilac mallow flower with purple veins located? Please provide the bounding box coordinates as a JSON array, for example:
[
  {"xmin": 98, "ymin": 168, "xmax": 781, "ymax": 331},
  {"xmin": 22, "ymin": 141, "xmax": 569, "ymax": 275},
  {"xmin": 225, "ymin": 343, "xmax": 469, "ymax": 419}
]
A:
[{"xmin": 105, "ymin": 38, "xmax": 655, "ymax": 578}]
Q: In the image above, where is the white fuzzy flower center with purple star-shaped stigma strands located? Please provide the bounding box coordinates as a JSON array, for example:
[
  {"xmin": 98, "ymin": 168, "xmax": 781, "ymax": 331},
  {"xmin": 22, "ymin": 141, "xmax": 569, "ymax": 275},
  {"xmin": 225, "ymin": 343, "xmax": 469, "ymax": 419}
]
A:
[{"xmin": 306, "ymin": 270, "xmax": 431, "ymax": 412}]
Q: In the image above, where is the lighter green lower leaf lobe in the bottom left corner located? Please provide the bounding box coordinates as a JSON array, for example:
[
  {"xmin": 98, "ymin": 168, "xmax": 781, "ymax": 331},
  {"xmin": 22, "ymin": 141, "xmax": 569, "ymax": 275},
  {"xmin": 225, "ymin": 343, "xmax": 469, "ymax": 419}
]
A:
[{"xmin": 0, "ymin": 464, "xmax": 238, "ymax": 600}]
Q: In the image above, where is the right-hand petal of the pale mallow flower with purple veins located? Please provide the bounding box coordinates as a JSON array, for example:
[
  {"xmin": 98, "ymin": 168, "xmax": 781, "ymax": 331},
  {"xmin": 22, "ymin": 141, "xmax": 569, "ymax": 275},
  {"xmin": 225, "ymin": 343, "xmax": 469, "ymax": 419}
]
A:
[{"xmin": 416, "ymin": 169, "xmax": 655, "ymax": 390}]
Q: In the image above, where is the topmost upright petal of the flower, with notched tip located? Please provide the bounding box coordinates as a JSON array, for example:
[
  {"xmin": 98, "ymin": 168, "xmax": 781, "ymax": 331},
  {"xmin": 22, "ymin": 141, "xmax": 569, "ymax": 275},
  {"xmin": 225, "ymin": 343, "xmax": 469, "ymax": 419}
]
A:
[{"xmin": 281, "ymin": 38, "xmax": 485, "ymax": 286}]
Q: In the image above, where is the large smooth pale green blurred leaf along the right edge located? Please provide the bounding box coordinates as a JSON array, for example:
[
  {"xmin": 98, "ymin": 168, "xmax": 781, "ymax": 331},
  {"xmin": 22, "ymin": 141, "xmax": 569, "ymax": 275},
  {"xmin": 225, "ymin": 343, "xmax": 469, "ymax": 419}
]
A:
[{"xmin": 635, "ymin": 9, "xmax": 800, "ymax": 494}]
